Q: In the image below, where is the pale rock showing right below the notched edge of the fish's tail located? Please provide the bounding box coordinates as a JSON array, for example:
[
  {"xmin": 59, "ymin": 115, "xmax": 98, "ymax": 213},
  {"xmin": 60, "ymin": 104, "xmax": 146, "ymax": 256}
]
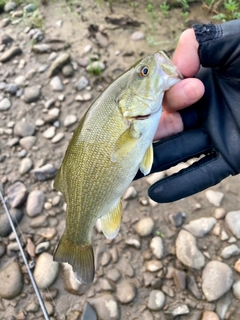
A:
[{"xmin": 62, "ymin": 263, "xmax": 89, "ymax": 295}]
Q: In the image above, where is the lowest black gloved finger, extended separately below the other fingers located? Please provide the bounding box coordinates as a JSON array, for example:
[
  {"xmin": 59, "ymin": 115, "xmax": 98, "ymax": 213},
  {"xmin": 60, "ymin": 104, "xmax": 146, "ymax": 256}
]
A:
[{"xmin": 148, "ymin": 153, "xmax": 235, "ymax": 203}]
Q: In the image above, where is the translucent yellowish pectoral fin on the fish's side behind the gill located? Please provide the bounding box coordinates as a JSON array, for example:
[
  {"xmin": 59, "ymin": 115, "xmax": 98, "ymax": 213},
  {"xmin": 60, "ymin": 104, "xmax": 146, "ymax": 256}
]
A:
[{"xmin": 111, "ymin": 125, "xmax": 141, "ymax": 162}]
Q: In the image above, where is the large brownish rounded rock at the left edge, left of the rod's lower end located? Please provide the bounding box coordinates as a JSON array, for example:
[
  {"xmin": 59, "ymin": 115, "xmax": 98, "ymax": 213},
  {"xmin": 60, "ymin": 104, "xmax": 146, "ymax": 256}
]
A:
[{"xmin": 0, "ymin": 262, "xmax": 23, "ymax": 300}]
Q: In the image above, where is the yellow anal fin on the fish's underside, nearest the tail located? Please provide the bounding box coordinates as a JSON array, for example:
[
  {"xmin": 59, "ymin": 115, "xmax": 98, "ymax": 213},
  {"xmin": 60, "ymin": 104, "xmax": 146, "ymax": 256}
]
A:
[{"xmin": 101, "ymin": 199, "xmax": 122, "ymax": 239}]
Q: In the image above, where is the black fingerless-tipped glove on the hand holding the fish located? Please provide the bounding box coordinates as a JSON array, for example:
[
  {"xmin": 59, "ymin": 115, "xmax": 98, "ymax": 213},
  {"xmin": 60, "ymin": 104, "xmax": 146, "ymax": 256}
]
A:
[{"xmin": 149, "ymin": 19, "xmax": 240, "ymax": 203}]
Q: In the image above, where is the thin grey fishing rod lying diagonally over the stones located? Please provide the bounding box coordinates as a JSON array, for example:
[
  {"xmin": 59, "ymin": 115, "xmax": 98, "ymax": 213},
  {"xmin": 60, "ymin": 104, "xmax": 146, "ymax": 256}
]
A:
[{"xmin": 0, "ymin": 190, "xmax": 49, "ymax": 320}]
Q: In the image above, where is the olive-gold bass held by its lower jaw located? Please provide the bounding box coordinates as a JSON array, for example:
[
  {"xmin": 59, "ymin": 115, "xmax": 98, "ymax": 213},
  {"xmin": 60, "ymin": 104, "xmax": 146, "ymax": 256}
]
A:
[{"xmin": 54, "ymin": 51, "xmax": 182, "ymax": 285}]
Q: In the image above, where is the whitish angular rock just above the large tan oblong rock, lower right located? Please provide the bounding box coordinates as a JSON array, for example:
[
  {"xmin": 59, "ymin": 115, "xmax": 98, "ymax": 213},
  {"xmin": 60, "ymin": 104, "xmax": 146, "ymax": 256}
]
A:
[{"xmin": 183, "ymin": 217, "xmax": 217, "ymax": 237}]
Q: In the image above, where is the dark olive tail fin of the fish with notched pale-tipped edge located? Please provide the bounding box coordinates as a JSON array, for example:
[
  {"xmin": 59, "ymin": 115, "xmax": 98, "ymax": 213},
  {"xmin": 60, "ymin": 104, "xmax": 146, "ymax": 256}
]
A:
[{"xmin": 53, "ymin": 235, "xmax": 95, "ymax": 285}]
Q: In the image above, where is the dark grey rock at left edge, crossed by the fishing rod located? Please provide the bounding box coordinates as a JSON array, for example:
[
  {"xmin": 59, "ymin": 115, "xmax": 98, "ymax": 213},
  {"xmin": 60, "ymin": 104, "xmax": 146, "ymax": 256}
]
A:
[{"xmin": 0, "ymin": 208, "xmax": 23, "ymax": 237}]
